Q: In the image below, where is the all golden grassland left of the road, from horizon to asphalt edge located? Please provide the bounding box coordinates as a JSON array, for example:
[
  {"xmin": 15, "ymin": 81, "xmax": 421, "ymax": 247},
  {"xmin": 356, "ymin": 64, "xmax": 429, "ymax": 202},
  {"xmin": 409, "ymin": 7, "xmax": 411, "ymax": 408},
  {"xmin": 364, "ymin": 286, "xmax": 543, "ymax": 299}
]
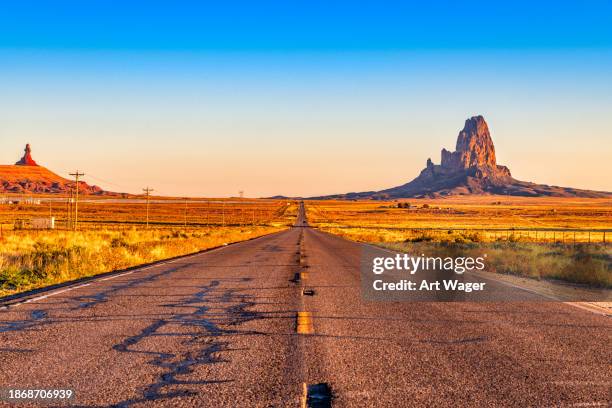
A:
[{"xmin": 0, "ymin": 197, "xmax": 298, "ymax": 296}]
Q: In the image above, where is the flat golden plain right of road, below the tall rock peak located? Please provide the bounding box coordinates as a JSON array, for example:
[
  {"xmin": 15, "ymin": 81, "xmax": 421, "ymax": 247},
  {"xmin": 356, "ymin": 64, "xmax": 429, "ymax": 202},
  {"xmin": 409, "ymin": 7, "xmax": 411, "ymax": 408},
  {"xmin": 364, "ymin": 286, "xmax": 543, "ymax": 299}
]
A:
[{"xmin": 307, "ymin": 196, "xmax": 612, "ymax": 242}]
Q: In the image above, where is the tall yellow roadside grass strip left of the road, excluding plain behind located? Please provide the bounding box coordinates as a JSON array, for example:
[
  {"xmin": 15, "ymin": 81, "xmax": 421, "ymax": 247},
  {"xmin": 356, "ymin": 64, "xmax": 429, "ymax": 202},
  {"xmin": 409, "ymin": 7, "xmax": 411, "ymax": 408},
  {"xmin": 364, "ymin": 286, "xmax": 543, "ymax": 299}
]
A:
[{"xmin": 0, "ymin": 226, "xmax": 283, "ymax": 296}]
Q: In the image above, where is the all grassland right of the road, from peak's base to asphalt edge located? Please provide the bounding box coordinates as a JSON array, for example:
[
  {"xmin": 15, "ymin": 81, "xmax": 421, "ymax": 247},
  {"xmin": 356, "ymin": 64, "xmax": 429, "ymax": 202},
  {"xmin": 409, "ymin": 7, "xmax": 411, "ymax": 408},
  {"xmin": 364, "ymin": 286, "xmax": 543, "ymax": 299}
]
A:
[{"xmin": 306, "ymin": 196, "xmax": 612, "ymax": 288}]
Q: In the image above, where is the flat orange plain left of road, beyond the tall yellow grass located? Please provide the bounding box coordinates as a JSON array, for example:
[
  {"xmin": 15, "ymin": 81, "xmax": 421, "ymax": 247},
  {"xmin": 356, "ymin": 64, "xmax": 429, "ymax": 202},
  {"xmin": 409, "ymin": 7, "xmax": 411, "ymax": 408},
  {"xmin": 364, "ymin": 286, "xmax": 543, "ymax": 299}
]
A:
[{"xmin": 0, "ymin": 198, "xmax": 293, "ymax": 233}]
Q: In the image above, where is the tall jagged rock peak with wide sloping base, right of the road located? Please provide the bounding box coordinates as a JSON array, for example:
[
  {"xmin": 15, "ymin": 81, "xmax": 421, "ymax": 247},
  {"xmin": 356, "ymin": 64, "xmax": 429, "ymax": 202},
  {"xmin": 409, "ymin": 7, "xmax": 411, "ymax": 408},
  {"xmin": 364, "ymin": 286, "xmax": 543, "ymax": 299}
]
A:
[{"xmin": 315, "ymin": 116, "xmax": 612, "ymax": 200}]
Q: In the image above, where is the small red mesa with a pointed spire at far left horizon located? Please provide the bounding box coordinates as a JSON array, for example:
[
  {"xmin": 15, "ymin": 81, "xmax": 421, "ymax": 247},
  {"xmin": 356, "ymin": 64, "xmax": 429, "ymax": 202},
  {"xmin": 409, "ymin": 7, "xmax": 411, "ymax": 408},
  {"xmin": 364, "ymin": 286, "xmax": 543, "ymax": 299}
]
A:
[{"xmin": 0, "ymin": 144, "xmax": 110, "ymax": 195}]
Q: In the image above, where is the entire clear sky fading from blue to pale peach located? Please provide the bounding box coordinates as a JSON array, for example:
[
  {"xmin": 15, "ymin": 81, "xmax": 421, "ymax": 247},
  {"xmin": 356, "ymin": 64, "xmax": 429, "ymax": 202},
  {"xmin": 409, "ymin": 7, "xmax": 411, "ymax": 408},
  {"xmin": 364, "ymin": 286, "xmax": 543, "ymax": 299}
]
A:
[{"xmin": 0, "ymin": 0, "xmax": 612, "ymax": 196}]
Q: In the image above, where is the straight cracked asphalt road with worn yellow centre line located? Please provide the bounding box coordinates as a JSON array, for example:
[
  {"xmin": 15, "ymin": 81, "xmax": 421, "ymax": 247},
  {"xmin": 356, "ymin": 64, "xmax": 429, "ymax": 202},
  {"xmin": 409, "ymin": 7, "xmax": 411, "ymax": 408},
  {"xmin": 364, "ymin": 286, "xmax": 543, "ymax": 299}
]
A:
[{"xmin": 0, "ymin": 206, "xmax": 612, "ymax": 407}]
